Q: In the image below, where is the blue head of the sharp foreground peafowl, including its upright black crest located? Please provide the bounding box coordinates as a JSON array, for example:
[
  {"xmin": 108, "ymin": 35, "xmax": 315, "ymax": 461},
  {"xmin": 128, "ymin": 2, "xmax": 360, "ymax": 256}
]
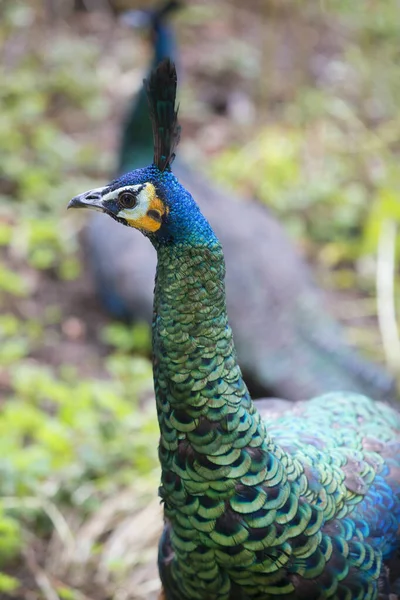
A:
[{"xmin": 68, "ymin": 59, "xmax": 216, "ymax": 247}]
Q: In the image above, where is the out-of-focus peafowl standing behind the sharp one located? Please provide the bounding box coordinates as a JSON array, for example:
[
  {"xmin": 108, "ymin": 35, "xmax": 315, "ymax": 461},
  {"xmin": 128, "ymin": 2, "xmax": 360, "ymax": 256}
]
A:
[{"xmin": 85, "ymin": 2, "xmax": 394, "ymax": 400}]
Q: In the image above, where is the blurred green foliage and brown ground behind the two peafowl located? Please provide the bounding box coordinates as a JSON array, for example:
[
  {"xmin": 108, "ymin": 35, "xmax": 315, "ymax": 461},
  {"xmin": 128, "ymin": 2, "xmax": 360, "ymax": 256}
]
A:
[{"xmin": 0, "ymin": 0, "xmax": 400, "ymax": 600}]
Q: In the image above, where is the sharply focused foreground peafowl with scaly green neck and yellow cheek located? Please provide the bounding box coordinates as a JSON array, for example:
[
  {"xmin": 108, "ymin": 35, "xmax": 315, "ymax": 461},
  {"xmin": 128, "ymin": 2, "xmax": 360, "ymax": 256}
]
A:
[{"xmin": 69, "ymin": 59, "xmax": 400, "ymax": 600}]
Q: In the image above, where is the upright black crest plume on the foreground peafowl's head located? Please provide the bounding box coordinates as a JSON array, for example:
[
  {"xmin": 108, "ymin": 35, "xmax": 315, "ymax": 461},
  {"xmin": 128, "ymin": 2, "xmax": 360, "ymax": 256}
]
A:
[{"xmin": 144, "ymin": 58, "xmax": 181, "ymax": 171}]
